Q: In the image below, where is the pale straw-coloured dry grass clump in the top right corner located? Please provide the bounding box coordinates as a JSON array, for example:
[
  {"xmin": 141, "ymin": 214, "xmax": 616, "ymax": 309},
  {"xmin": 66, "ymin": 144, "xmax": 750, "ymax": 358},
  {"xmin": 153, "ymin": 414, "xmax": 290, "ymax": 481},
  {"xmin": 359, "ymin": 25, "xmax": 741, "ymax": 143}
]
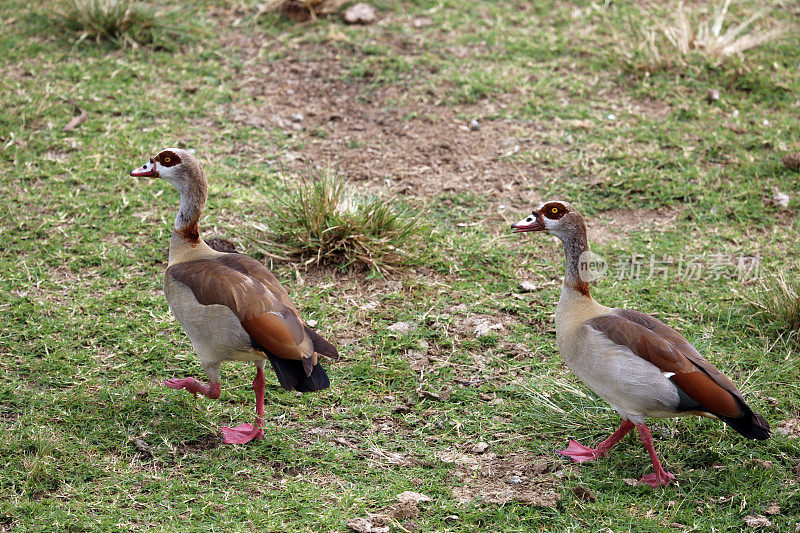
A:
[{"xmin": 616, "ymin": 0, "xmax": 785, "ymax": 72}]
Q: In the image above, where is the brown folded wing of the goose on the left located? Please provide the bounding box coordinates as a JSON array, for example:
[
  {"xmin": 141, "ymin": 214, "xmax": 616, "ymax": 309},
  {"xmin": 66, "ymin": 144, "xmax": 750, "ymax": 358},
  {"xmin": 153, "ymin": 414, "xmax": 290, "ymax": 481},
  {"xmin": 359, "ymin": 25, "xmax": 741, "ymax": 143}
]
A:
[{"xmin": 167, "ymin": 254, "xmax": 317, "ymax": 366}]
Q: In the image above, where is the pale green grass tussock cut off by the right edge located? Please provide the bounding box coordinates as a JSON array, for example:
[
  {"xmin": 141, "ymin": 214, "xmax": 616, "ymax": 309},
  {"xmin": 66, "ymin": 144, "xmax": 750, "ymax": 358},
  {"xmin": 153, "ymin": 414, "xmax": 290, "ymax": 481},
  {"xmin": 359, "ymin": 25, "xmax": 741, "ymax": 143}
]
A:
[{"xmin": 748, "ymin": 273, "xmax": 800, "ymax": 338}]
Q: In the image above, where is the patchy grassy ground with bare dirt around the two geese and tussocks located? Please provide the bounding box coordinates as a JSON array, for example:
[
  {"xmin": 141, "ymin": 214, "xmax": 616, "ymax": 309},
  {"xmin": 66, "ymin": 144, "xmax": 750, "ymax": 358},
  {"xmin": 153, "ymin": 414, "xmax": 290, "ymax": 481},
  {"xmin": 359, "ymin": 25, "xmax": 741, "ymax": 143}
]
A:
[{"xmin": 0, "ymin": 0, "xmax": 800, "ymax": 531}]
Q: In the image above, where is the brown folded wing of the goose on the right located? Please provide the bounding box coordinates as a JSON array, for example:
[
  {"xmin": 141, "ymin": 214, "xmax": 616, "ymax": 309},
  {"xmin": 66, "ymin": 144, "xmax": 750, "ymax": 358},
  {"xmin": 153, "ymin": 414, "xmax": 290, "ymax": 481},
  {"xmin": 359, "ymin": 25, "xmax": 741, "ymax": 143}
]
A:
[{"xmin": 588, "ymin": 309, "xmax": 746, "ymax": 418}]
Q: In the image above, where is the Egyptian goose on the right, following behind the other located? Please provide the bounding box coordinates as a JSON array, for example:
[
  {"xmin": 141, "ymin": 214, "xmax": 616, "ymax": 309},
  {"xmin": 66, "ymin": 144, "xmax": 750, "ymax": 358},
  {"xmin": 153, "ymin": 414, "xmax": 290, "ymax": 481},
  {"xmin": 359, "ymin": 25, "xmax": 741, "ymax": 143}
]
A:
[{"xmin": 511, "ymin": 202, "xmax": 769, "ymax": 487}]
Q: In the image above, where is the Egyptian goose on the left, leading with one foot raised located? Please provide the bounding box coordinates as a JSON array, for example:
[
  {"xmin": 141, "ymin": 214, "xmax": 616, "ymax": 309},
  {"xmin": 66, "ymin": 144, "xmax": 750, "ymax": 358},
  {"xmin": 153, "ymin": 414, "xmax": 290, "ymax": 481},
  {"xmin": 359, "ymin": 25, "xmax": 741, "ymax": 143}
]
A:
[{"xmin": 131, "ymin": 148, "xmax": 338, "ymax": 444}]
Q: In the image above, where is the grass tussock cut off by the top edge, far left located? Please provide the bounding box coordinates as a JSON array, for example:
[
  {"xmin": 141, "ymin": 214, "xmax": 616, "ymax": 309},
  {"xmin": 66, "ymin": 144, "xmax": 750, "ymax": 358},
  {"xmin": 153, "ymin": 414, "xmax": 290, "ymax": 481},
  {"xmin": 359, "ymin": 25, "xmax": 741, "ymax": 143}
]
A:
[{"xmin": 55, "ymin": 0, "xmax": 158, "ymax": 46}]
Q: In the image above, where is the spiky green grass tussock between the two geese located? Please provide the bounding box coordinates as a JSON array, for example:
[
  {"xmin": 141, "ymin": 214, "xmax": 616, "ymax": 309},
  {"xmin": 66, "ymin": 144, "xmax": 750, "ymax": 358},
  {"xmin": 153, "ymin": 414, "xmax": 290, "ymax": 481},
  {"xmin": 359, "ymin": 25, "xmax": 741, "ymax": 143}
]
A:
[{"xmin": 260, "ymin": 171, "xmax": 428, "ymax": 272}]
